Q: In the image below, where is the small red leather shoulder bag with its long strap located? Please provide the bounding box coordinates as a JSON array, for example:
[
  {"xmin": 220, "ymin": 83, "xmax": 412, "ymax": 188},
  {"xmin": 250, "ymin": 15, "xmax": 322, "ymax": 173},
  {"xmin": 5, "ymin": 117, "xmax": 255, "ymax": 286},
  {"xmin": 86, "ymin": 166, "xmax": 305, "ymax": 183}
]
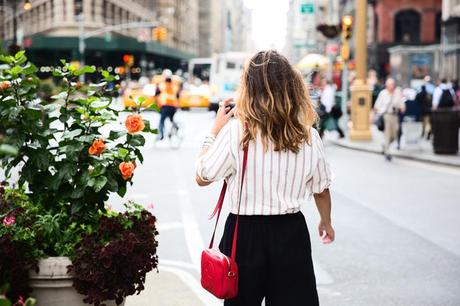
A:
[{"xmin": 201, "ymin": 147, "xmax": 248, "ymax": 299}]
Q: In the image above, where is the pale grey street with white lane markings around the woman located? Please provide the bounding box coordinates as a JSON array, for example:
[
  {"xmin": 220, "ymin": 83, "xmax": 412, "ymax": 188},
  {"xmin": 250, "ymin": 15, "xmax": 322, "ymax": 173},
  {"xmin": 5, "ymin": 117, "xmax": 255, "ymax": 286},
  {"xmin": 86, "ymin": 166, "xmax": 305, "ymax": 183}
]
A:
[{"xmin": 110, "ymin": 111, "xmax": 460, "ymax": 306}]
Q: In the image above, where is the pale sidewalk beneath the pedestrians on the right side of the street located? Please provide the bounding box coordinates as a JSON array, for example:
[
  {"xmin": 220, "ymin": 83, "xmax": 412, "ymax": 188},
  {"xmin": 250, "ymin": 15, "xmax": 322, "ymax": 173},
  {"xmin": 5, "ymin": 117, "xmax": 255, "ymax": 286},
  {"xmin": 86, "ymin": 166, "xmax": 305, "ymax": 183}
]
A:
[{"xmin": 325, "ymin": 125, "xmax": 460, "ymax": 167}]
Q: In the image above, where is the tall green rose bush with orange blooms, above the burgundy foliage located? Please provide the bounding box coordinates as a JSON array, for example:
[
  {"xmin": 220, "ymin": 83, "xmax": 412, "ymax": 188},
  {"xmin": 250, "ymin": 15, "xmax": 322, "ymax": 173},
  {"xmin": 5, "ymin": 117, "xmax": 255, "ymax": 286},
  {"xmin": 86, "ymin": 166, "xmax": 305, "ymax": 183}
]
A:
[{"xmin": 0, "ymin": 52, "xmax": 156, "ymax": 219}]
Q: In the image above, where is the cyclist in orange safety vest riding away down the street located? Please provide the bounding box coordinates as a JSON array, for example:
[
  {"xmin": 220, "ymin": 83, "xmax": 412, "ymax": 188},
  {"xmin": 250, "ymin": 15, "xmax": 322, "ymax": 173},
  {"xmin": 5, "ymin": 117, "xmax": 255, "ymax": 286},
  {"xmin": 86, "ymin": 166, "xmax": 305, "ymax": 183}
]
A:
[{"xmin": 155, "ymin": 77, "xmax": 180, "ymax": 140}]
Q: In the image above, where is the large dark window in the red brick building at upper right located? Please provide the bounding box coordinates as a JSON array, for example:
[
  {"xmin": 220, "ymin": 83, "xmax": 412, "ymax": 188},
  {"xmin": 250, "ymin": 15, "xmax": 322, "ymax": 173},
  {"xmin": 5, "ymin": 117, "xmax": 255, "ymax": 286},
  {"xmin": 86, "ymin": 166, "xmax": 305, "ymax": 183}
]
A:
[{"xmin": 394, "ymin": 10, "xmax": 421, "ymax": 43}]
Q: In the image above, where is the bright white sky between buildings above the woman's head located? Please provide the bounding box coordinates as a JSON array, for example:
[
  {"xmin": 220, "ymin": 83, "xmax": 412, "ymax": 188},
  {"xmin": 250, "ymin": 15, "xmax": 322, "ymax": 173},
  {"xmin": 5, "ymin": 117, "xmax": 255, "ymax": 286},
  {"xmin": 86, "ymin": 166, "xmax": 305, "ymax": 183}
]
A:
[{"xmin": 244, "ymin": 0, "xmax": 289, "ymax": 50}]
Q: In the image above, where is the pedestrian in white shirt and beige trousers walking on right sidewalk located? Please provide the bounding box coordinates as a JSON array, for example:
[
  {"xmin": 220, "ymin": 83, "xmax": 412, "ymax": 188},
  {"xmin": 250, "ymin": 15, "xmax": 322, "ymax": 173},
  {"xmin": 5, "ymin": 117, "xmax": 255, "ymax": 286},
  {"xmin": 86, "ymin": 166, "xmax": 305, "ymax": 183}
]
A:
[{"xmin": 374, "ymin": 78, "xmax": 405, "ymax": 161}]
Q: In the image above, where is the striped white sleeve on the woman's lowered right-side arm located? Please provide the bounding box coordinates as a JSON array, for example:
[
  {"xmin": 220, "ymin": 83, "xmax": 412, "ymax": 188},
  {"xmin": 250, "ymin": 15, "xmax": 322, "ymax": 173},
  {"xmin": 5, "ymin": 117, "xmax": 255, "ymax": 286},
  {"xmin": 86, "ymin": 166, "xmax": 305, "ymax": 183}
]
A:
[{"xmin": 307, "ymin": 129, "xmax": 332, "ymax": 194}]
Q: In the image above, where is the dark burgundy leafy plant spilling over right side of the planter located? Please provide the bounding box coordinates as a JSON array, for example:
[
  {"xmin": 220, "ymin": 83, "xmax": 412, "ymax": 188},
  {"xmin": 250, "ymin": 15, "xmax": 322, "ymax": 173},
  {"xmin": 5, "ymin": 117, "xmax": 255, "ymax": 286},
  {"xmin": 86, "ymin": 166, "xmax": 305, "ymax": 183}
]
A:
[{"xmin": 69, "ymin": 203, "xmax": 158, "ymax": 306}]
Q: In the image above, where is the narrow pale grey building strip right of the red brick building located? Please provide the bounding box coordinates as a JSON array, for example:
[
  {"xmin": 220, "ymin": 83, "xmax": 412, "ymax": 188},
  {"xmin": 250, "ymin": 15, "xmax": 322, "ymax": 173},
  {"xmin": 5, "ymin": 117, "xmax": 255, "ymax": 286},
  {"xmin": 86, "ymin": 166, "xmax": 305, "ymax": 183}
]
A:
[{"xmin": 441, "ymin": 0, "xmax": 460, "ymax": 80}]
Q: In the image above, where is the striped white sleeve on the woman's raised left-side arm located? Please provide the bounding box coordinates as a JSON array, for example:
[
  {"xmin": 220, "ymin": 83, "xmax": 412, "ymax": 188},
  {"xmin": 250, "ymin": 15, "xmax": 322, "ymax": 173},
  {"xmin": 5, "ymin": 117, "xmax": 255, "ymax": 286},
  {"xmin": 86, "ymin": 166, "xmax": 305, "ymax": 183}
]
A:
[{"xmin": 196, "ymin": 124, "xmax": 236, "ymax": 182}]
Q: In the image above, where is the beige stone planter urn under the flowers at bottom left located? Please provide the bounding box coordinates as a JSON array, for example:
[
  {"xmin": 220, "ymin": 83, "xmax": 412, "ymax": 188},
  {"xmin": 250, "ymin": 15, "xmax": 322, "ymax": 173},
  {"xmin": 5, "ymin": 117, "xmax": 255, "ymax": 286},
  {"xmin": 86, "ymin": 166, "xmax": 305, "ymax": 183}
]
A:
[{"xmin": 29, "ymin": 257, "xmax": 124, "ymax": 306}]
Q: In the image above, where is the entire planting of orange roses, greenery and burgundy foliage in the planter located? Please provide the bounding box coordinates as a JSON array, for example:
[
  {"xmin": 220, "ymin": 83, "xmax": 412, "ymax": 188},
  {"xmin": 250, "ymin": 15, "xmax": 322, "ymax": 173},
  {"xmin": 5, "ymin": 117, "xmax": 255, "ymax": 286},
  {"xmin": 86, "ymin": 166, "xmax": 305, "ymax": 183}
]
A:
[{"xmin": 0, "ymin": 51, "xmax": 158, "ymax": 305}]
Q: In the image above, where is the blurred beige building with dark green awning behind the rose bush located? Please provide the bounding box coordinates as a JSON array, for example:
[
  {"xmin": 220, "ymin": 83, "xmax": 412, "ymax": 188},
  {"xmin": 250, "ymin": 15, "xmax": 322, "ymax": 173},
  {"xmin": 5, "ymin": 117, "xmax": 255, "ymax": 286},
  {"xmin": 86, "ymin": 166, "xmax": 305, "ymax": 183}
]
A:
[{"xmin": 0, "ymin": 0, "xmax": 199, "ymax": 74}]
